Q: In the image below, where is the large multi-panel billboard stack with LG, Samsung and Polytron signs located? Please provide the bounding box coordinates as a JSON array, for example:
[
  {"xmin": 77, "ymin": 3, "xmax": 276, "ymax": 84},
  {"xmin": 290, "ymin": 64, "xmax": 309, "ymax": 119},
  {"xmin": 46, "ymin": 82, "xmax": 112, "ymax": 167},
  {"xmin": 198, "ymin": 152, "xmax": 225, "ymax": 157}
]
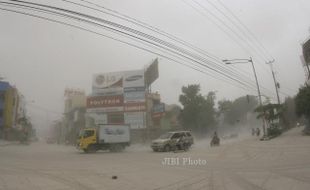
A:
[{"xmin": 87, "ymin": 67, "xmax": 152, "ymax": 129}]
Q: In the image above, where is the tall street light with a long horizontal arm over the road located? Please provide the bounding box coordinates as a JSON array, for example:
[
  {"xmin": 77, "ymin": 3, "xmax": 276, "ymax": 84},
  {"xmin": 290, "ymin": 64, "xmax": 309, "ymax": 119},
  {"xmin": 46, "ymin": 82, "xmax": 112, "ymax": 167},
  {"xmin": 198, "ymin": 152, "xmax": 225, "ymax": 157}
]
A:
[{"xmin": 223, "ymin": 57, "xmax": 266, "ymax": 137}]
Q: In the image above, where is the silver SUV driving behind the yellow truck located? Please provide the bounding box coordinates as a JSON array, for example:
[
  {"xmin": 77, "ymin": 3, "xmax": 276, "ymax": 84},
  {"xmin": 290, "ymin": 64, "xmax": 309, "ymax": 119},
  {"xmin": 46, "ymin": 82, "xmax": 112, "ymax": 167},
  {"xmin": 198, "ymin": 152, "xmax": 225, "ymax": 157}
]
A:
[{"xmin": 151, "ymin": 131, "xmax": 194, "ymax": 152}]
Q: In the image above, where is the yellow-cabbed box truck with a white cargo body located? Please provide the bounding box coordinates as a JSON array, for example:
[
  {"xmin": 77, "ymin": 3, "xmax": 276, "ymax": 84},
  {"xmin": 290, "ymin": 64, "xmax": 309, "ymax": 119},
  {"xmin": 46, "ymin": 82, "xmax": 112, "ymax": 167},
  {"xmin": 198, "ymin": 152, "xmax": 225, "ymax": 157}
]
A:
[{"xmin": 77, "ymin": 125, "xmax": 130, "ymax": 153}]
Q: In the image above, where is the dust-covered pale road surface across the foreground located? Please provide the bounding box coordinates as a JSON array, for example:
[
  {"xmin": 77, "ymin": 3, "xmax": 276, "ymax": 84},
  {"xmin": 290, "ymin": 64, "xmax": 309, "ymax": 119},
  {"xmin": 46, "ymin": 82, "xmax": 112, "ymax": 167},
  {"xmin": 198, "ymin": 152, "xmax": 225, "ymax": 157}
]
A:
[{"xmin": 0, "ymin": 128, "xmax": 310, "ymax": 190}]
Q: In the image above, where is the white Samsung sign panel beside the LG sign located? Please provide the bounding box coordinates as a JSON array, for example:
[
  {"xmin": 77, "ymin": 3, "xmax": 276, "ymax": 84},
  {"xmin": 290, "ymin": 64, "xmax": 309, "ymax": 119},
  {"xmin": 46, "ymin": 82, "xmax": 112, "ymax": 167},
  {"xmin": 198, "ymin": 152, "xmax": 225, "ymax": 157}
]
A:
[{"xmin": 123, "ymin": 70, "xmax": 144, "ymax": 88}]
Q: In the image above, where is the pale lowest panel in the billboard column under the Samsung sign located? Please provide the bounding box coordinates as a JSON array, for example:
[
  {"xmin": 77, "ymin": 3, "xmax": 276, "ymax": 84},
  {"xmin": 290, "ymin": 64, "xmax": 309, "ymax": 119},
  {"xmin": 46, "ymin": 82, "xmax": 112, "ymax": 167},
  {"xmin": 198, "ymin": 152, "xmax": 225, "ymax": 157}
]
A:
[{"xmin": 124, "ymin": 112, "xmax": 145, "ymax": 129}]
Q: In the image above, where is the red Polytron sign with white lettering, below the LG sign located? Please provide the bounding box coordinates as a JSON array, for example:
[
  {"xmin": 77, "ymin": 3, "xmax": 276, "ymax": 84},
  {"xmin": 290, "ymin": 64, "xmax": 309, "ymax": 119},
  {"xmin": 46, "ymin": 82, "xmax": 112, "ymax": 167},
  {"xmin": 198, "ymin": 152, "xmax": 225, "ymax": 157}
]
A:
[{"xmin": 87, "ymin": 95, "xmax": 124, "ymax": 108}]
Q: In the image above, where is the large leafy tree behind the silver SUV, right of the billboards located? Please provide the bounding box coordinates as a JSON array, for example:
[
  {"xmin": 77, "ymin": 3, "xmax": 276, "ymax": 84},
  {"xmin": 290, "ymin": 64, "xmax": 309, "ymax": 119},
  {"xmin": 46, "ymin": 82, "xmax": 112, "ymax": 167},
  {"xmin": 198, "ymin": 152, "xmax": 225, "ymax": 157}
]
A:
[{"xmin": 179, "ymin": 84, "xmax": 216, "ymax": 132}]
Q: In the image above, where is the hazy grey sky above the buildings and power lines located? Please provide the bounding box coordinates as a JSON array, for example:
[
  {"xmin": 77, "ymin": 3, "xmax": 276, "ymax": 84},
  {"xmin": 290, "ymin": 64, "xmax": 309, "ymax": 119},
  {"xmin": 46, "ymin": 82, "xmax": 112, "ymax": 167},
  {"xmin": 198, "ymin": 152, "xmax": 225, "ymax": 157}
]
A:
[{"xmin": 0, "ymin": 0, "xmax": 310, "ymax": 131}]
